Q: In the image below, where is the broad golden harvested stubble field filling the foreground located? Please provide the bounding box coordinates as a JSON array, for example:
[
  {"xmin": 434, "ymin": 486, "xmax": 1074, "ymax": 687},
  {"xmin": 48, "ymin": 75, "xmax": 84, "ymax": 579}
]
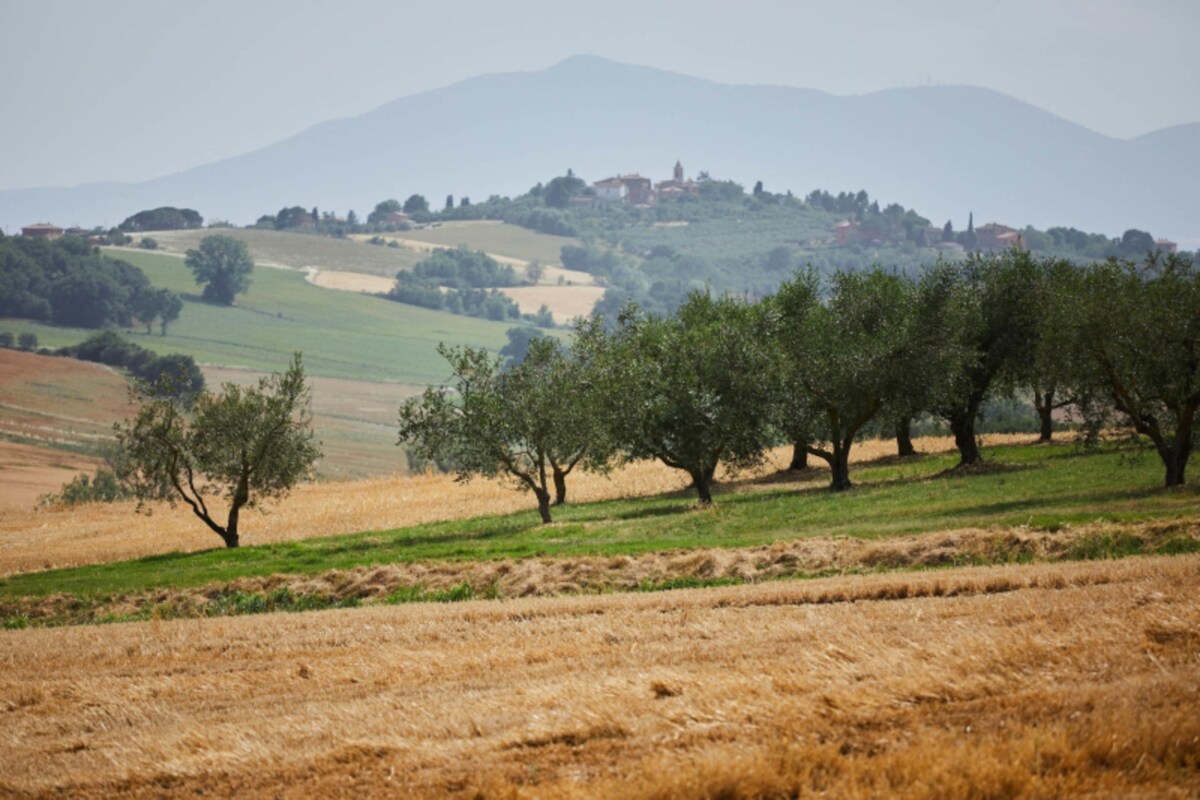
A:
[{"xmin": 0, "ymin": 557, "xmax": 1200, "ymax": 798}]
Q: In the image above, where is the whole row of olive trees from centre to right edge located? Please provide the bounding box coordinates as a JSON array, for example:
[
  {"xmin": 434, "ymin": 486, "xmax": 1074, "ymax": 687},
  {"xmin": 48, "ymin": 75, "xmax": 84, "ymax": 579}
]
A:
[{"xmin": 400, "ymin": 249, "xmax": 1200, "ymax": 522}]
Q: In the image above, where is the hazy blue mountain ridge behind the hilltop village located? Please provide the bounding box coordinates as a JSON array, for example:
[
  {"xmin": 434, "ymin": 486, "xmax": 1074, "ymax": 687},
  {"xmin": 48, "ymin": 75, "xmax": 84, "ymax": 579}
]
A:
[{"xmin": 0, "ymin": 56, "xmax": 1200, "ymax": 242}]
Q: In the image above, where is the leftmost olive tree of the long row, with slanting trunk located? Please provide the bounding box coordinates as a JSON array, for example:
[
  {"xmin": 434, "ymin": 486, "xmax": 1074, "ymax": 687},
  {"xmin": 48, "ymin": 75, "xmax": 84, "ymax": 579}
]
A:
[{"xmin": 397, "ymin": 337, "xmax": 611, "ymax": 523}]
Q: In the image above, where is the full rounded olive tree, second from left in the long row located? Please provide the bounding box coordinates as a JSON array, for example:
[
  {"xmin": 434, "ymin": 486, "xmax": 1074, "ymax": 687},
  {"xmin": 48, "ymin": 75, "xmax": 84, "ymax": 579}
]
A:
[{"xmin": 581, "ymin": 291, "xmax": 774, "ymax": 505}]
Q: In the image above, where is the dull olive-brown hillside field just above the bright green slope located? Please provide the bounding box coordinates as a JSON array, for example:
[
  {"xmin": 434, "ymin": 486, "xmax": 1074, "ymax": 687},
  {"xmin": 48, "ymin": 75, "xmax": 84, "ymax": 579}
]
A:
[{"xmin": 126, "ymin": 228, "xmax": 425, "ymax": 278}]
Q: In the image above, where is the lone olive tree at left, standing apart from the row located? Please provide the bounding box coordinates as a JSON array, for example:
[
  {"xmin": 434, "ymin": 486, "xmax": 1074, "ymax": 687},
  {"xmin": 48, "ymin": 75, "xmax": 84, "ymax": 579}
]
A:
[{"xmin": 116, "ymin": 353, "xmax": 320, "ymax": 547}]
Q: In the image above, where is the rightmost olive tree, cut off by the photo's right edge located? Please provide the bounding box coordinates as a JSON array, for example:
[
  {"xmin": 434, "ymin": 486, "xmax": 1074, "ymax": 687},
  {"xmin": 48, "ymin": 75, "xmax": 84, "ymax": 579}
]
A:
[{"xmin": 1058, "ymin": 254, "xmax": 1200, "ymax": 486}]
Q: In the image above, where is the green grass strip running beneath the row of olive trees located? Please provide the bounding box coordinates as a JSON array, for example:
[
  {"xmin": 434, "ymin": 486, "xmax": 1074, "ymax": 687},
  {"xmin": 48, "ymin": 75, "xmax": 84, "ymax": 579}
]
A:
[{"xmin": 0, "ymin": 445, "xmax": 1198, "ymax": 600}]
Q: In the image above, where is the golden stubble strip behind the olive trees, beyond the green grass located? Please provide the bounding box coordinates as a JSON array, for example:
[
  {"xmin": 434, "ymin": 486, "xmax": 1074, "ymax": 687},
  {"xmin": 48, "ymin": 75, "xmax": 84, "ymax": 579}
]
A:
[{"xmin": 0, "ymin": 435, "xmax": 1028, "ymax": 576}]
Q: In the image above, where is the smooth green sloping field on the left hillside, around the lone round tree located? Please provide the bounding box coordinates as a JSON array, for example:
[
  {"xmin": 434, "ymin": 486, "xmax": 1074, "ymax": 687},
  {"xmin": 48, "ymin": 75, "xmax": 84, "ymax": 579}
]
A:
[{"xmin": 0, "ymin": 251, "xmax": 510, "ymax": 385}]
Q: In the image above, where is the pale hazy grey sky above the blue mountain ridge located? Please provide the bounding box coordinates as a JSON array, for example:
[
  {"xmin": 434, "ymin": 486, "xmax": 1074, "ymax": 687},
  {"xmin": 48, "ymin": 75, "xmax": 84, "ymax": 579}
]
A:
[{"xmin": 0, "ymin": 0, "xmax": 1200, "ymax": 188}]
